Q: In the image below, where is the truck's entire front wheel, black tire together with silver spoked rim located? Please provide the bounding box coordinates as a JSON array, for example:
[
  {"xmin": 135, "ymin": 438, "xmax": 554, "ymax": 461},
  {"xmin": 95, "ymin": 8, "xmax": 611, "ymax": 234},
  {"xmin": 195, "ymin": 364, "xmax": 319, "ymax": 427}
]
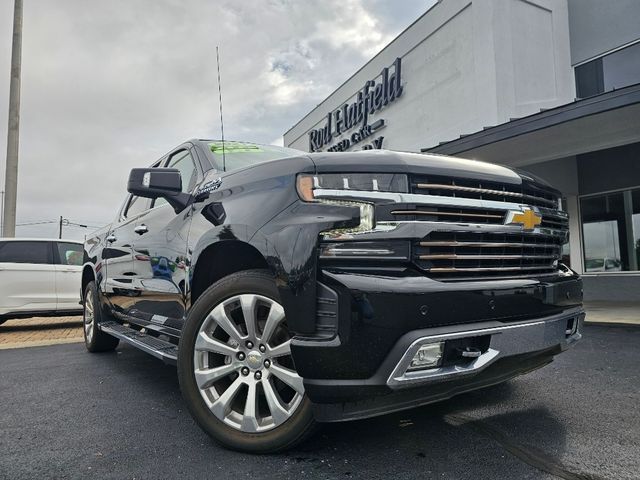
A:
[{"xmin": 178, "ymin": 270, "xmax": 315, "ymax": 453}]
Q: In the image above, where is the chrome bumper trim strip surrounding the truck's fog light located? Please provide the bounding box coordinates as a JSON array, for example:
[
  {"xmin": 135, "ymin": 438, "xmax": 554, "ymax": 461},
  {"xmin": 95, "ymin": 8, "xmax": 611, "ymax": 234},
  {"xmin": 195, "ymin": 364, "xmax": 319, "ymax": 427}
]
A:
[{"xmin": 387, "ymin": 308, "xmax": 584, "ymax": 390}]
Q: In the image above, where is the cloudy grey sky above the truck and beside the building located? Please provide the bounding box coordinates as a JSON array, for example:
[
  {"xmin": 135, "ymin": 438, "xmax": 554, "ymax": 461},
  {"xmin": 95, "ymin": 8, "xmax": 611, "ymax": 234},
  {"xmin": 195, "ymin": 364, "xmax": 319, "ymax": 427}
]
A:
[{"xmin": 0, "ymin": 0, "xmax": 435, "ymax": 239}]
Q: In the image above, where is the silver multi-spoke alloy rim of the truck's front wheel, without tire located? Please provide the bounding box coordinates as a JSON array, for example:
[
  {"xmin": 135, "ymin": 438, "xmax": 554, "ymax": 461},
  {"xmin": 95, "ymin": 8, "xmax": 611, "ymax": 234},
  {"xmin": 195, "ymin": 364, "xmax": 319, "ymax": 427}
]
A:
[{"xmin": 194, "ymin": 294, "xmax": 304, "ymax": 433}]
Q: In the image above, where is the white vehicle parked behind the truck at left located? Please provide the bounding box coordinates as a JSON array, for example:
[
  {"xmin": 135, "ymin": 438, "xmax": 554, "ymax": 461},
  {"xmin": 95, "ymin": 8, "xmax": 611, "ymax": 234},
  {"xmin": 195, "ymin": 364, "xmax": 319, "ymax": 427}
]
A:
[{"xmin": 0, "ymin": 238, "xmax": 84, "ymax": 323}]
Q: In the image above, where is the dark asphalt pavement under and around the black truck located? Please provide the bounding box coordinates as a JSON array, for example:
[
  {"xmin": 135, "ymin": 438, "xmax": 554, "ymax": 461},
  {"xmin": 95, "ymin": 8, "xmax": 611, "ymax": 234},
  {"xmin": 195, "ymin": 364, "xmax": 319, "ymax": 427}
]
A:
[{"xmin": 0, "ymin": 325, "xmax": 640, "ymax": 480}]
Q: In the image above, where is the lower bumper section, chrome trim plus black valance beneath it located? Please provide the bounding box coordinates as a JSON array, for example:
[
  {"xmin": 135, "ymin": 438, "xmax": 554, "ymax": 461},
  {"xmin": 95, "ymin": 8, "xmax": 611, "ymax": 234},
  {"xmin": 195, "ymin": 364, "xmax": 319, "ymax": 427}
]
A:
[{"xmin": 305, "ymin": 308, "xmax": 584, "ymax": 422}]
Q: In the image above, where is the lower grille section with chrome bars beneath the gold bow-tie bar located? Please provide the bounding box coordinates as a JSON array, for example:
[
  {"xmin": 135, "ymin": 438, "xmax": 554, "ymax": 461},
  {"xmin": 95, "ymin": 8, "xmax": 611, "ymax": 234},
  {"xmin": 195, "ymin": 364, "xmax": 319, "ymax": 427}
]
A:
[{"xmin": 413, "ymin": 231, "xmax": 562, "ymax": 279}]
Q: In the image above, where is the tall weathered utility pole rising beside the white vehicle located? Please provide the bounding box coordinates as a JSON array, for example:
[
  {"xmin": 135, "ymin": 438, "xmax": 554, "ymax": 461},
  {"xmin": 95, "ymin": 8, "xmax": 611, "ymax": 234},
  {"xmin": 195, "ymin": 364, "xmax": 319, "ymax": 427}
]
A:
[{"xmin": 2, "ymin": 0, "xmax": 22, "ymax": 237}]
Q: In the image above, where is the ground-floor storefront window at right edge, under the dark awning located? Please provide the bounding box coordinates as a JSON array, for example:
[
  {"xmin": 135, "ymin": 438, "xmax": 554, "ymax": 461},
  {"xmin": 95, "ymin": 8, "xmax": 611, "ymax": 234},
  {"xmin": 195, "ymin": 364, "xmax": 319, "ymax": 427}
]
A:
[{"xmin": 580, "ymin": 189, "xmax": 640, "ymax": 273}]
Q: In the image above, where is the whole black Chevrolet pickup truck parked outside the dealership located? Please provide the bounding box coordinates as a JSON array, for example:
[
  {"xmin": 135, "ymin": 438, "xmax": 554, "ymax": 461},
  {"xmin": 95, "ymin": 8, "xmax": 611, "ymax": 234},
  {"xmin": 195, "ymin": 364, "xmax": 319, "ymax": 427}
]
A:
[{"xmin": 82, "ymin": 140, "xmax": 584, "ymax": 452}]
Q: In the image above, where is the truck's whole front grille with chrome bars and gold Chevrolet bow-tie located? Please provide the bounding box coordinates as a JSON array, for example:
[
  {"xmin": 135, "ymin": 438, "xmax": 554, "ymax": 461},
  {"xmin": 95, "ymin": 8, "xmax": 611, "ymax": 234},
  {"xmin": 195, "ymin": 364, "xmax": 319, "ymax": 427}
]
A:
[{"xmin": 316, "ymin": 175, "xmax": 569, "ymax": 281}]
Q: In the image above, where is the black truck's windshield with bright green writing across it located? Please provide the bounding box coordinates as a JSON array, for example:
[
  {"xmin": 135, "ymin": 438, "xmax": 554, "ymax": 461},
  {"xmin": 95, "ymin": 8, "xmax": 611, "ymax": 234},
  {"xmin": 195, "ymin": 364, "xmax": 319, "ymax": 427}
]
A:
[{"xmin": 207, "ymin": 141, "xmax": 304, "ymax": 172}]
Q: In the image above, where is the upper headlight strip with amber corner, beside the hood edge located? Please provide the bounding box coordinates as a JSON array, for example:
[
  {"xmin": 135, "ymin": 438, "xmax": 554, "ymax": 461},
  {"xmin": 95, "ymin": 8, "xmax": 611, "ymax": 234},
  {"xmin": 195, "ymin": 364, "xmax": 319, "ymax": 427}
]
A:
[{"xmin": 296, "ymin": 173, "xmax": 409, "ymax": 202}]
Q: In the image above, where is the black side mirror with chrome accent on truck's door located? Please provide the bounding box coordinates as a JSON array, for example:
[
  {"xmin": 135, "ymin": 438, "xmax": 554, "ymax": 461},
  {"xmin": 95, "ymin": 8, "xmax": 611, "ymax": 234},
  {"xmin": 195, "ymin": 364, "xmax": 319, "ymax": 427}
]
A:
[{"xmin": 127, "ymin": 168, "xmax": 192, "ymax": 213}]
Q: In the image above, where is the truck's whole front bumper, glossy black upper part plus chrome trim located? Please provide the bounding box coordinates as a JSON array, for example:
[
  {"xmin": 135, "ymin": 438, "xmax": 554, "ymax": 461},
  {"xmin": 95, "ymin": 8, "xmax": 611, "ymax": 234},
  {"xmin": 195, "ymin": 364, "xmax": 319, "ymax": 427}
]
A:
[{"xmin": 292, "ymin": 272, "xmax": 584, "ymax": 421}]
